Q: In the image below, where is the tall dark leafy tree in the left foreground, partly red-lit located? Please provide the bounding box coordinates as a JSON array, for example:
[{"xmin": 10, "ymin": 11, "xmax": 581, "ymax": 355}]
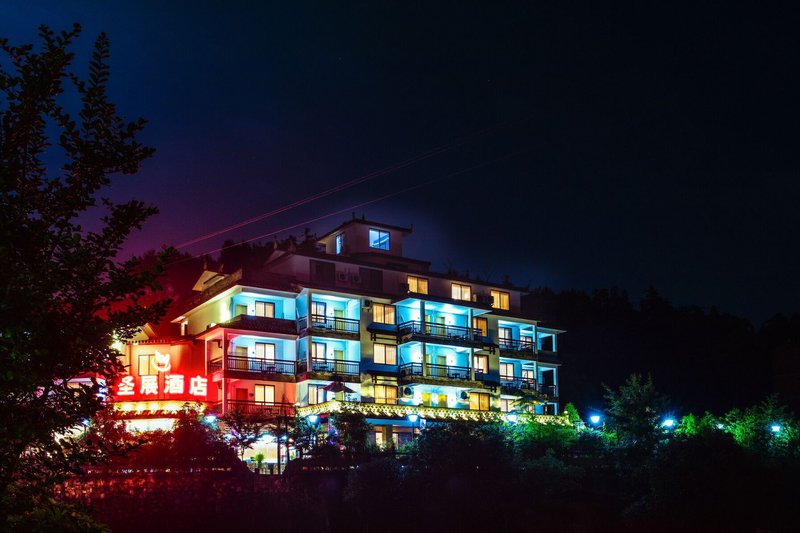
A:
[{"xmin": 0, "ymin": 25, "xmax": 166, "ymax": 515}]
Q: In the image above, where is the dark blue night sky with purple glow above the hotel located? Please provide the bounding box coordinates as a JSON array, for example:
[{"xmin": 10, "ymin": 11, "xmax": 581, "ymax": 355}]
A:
[{"xmin": 0, "ymin": 0, "xmax": 800, "ymax": 321}]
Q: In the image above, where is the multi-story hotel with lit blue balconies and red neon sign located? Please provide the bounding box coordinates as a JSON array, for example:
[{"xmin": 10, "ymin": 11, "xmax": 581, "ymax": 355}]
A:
[{"xmin": 111, "ymin": 219, "xmax": 561, "ymax": 456}]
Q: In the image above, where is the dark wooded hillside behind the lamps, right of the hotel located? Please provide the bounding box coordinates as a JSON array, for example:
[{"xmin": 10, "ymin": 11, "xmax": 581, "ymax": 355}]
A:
[{"xmin": 524, "ymin": 288, "xmax": 800, "ymax": 415}]
